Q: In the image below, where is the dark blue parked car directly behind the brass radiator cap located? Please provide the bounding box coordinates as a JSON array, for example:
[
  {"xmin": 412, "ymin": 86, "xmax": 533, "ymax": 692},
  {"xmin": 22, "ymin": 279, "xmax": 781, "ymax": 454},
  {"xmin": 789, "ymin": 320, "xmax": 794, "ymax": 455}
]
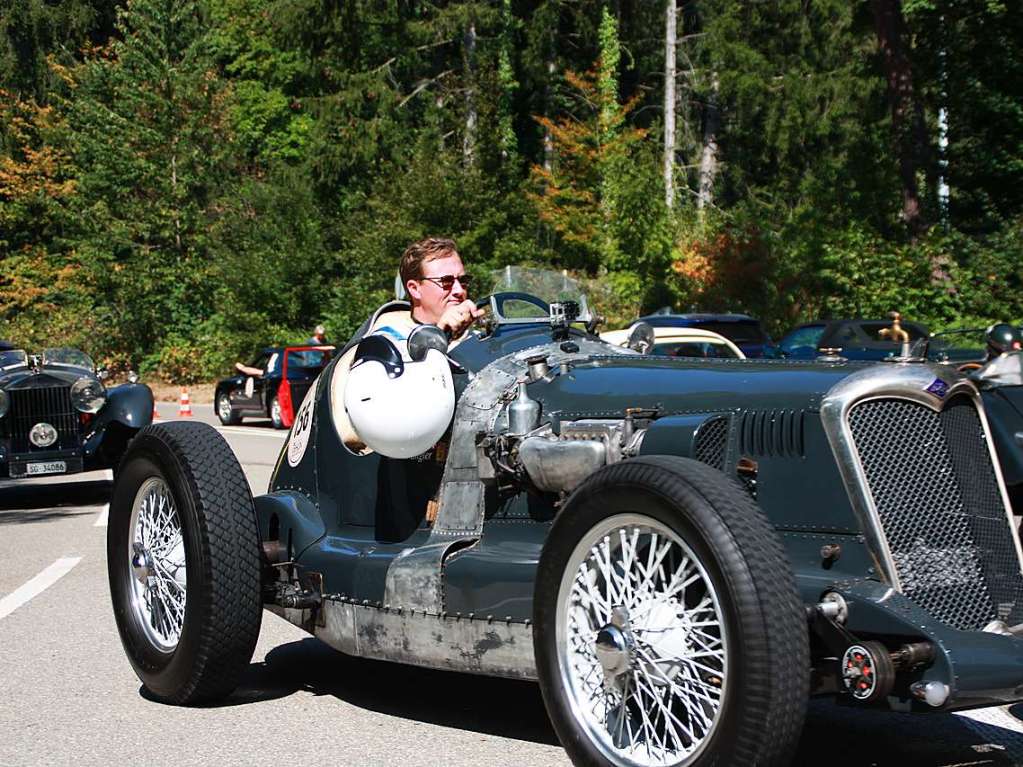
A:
[{"xmin": 779, "ymin": 319, "xmax": 930, "ymax": 360}]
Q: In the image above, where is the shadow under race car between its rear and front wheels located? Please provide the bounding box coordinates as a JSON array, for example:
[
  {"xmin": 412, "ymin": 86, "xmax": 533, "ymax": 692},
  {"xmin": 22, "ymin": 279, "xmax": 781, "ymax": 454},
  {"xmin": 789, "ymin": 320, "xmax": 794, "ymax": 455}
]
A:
[{"xmin": 151, "ymin": 638, "xmax": 558, "ymax": 745}]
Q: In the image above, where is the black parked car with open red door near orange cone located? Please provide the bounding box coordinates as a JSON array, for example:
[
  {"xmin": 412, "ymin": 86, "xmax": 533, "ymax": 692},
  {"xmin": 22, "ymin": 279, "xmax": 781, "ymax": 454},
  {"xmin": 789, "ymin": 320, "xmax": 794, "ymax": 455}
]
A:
[{"xmin": 214, "ymin": 346, "xmax": 335, "ymax": 428}]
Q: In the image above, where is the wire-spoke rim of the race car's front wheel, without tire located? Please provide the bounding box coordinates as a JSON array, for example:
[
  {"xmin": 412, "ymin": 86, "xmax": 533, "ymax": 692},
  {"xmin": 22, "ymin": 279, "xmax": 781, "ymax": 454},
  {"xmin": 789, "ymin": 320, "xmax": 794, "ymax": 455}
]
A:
[{"xmin": 557, "ymin": 513, "xmax": 728, "ymax": 767}]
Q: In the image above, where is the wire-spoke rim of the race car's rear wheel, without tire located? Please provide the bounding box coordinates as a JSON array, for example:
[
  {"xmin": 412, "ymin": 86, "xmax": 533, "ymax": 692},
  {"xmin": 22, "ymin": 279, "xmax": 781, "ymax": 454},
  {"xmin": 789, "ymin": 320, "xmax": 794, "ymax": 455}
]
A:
[{"xmin": 128, "ymin": 477, "xmax": 188, "ymax": 652}]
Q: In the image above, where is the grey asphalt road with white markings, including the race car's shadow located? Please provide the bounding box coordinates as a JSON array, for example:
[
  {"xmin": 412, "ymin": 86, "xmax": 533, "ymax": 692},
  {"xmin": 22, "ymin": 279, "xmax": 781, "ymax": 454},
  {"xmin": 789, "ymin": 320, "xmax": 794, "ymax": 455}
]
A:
[{"xmin": 0, "ymin": 405, "xmax": 1023, "ymax": 767}]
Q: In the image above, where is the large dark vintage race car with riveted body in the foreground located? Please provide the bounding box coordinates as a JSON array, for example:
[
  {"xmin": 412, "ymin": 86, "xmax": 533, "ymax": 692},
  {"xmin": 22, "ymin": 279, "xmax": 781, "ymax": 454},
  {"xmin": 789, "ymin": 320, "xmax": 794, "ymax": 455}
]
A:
[{"xmin": 107, "ymin": 274, "xmax": 1023, "ymax": 766}]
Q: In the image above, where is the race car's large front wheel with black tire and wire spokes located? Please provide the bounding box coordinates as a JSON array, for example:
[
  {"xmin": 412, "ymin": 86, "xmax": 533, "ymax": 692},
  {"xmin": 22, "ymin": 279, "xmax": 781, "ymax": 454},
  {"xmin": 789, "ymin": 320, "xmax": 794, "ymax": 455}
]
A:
[{"xmin": 534, "ymin": 457, "xmax": 809, "ymax": 767}]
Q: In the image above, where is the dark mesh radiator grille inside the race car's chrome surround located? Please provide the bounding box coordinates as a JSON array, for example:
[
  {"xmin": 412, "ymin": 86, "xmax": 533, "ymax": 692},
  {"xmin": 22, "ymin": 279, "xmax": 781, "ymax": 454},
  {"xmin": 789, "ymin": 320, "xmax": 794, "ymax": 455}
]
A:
[{"xmin": 849, "ymin": 396, "xmax": 1023, "ymax": 630}]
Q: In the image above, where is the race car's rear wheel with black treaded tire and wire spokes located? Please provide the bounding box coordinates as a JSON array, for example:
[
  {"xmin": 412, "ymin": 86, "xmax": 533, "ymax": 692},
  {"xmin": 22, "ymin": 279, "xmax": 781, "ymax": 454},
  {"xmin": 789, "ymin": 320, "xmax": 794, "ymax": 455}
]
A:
[{"xmin": 106, "ymin": 422, "xmax": 262, "ymax": 705}]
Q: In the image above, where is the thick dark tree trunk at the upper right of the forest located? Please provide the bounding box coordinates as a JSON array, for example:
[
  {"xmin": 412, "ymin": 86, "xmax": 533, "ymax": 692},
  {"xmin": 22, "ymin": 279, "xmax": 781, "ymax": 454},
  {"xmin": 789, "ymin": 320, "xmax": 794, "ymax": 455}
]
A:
[{"xmin": 871, "ymin": 0, "xmax": 926, "ymax": 237}]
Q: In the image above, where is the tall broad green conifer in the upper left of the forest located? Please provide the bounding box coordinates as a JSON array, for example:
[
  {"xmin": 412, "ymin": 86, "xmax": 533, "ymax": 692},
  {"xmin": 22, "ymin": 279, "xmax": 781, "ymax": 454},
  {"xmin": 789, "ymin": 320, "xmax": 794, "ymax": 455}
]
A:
[{"xmin": 71, "ymin": 0, "xmax": 230, "ymax": 362}]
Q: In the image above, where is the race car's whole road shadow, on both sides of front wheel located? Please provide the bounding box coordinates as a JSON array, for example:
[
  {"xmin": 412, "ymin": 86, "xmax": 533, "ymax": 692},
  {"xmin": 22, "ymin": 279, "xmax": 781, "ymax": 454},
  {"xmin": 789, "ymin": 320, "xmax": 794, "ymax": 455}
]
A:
[{"xmin": 139, "ymin": 638, "xmax": 1023, "ymax": 767}]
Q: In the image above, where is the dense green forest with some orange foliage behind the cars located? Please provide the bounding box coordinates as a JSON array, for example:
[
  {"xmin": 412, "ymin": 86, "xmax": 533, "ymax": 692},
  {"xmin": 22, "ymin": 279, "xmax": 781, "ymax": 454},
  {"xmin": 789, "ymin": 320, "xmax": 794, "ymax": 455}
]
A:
[{"xmin": 0, "ymin": 0, "xmax": 1023, "ymax": 382}]
